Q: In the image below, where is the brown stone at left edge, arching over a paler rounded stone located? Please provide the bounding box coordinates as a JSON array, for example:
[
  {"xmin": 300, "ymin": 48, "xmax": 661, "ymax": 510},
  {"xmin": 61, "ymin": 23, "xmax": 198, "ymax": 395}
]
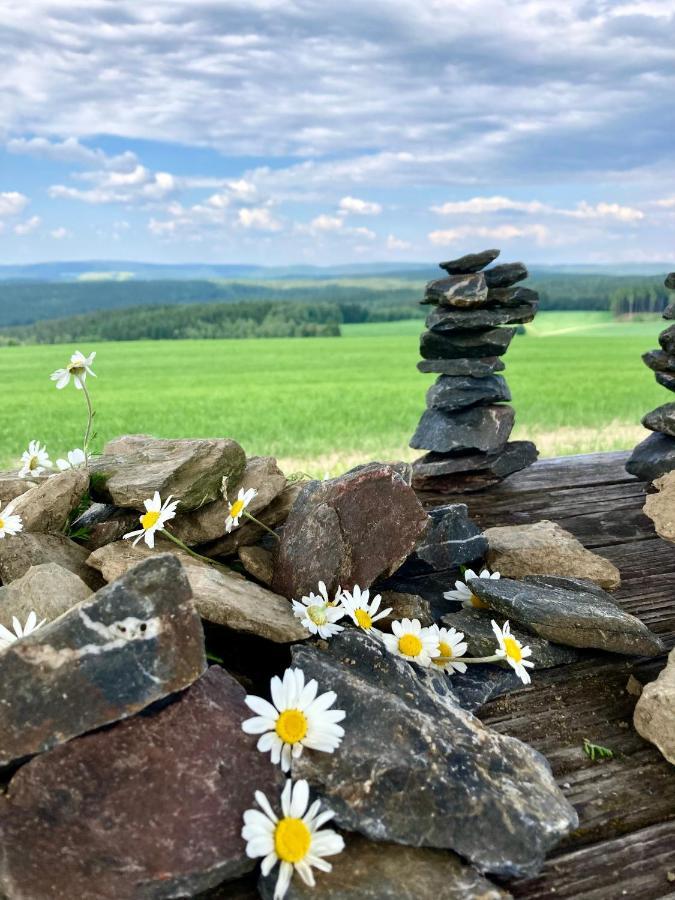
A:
[{"xmin": 0, "ymin": 531, "xmax": 103, "ymax": 591}]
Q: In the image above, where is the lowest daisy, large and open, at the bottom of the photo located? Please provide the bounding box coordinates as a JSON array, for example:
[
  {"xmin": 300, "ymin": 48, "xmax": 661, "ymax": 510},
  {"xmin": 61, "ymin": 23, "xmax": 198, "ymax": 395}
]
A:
[{"xmin": 241, "ymin": 779, "xmax": 345, "ymax": 900}]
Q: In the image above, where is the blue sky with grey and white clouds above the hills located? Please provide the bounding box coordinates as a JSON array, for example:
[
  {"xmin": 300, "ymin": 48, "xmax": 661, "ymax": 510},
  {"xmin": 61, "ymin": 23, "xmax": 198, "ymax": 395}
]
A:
[{"xmin": 0, "ymin": 0, "xmax": 675, "ymax": 265}]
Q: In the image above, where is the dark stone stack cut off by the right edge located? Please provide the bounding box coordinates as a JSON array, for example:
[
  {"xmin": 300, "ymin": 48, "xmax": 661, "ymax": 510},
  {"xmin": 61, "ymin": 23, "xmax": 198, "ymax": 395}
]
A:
[{"xmin": 626, "ymin": 272, "xmax": 675, "ymax": 481}]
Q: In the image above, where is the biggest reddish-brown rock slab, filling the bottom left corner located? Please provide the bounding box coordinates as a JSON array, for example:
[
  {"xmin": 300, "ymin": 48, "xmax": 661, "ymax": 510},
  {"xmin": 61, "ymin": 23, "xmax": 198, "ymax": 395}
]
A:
[{"xmin": 0, "ymin": 667, "xmax": 280, "ymax": 900}]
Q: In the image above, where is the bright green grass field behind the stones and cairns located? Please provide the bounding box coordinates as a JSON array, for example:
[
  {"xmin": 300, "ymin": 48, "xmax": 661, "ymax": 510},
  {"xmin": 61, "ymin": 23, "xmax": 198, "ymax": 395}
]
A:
[{"xmin": 0, "ymin": 313, "xmax": 671, "ymax": 474}]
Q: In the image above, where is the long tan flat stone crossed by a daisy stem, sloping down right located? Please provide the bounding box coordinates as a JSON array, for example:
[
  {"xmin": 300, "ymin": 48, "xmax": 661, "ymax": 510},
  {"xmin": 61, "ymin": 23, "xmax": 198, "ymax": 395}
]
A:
[{"xmin": 89, "ymin": 540, "xmax": 308, "ymax": 643}]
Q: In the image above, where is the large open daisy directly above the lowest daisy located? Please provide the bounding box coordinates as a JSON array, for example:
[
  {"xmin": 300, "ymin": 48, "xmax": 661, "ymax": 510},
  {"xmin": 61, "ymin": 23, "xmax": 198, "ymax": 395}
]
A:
[{"xmin": 241, "ymin": 669, "xmax": 345, "ymax": 772}]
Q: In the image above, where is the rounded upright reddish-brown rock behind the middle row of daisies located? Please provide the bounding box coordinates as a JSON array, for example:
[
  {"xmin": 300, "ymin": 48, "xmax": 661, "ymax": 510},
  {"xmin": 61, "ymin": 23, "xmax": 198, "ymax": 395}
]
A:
[{"xmin": 272, "ymin": 463, "xmax": 428, "ymax": 598}]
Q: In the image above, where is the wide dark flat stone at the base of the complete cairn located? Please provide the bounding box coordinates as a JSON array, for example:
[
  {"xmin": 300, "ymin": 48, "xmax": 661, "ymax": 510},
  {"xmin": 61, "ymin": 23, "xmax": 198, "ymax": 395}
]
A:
[{"xmin": 412, "ymin": 441, "xmax": 539, "ymax": 493}]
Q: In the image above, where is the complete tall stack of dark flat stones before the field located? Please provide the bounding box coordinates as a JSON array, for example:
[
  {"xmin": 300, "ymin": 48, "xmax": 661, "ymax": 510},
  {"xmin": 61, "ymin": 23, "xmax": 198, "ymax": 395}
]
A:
[{"xmin": 410, "ymin": 250, "xmax": 540, "ymax": 492}]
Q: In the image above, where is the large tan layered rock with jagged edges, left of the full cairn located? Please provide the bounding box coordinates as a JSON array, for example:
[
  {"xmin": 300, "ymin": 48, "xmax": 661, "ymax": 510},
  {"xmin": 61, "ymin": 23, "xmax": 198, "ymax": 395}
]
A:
[{"xmin": 91, "ymin": 434, "xmax": 246, "ymax": 511}]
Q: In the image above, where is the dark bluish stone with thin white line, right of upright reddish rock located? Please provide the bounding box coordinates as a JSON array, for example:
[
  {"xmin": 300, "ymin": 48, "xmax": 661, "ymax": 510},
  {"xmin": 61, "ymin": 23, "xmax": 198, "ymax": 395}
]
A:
[{"xmin": 415, "ymin": 503, "xmax": 488, "ymax": 569}]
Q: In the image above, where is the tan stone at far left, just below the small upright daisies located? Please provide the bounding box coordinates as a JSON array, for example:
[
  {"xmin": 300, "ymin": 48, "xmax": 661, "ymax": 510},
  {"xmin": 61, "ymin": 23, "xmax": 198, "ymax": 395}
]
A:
[{"xmin": 14, "ymin": 469, "xmax": 89, "ymax": 533}]
